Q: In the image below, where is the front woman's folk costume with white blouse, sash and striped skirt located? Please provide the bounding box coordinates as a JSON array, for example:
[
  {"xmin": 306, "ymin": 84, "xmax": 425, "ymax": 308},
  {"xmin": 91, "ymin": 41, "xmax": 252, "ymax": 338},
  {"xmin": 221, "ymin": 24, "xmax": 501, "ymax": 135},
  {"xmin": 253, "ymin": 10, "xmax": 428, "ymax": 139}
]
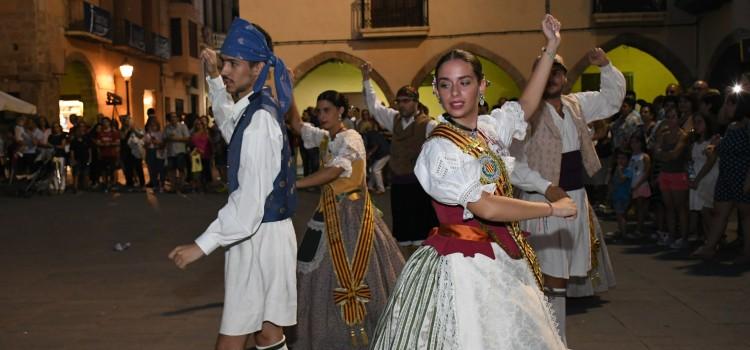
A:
[{"xmin": 371, "ymin": 102, "xmax": 565, "ymax": 349}]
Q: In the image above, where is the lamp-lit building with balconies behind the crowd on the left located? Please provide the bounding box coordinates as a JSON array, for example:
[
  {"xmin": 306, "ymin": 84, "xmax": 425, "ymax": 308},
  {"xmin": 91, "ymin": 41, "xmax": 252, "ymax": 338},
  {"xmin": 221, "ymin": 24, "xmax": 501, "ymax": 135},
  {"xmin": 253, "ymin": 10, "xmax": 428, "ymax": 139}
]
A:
[{"xmin": 0, "ymin": 0, "xmax": 237, "ymax": 127}]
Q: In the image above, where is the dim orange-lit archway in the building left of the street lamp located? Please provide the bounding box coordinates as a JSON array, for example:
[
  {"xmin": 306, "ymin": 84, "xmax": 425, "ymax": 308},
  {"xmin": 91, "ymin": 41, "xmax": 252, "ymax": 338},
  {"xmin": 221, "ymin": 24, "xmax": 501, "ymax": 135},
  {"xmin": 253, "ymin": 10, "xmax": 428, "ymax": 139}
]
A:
[{"xmin": 59, "ymin": 52, "xmax": 99, "ymax": 123}]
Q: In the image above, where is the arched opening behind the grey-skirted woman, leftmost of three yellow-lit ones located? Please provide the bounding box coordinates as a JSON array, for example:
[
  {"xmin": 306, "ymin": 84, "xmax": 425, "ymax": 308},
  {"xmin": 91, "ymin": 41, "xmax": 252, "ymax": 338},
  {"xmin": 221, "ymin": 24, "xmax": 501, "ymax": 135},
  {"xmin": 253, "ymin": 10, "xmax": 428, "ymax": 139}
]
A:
[{"xmin": 294, "ymin": 52, "xmax": 393, "ymax": 115}]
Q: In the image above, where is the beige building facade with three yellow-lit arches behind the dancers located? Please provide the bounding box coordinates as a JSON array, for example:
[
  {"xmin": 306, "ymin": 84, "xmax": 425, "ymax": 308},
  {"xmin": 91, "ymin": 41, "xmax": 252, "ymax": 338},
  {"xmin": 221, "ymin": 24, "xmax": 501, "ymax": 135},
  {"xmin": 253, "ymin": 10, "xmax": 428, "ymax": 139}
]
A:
[{"xmin": 239, "ymin": 0, "xmax": 750, "ymax": 115}]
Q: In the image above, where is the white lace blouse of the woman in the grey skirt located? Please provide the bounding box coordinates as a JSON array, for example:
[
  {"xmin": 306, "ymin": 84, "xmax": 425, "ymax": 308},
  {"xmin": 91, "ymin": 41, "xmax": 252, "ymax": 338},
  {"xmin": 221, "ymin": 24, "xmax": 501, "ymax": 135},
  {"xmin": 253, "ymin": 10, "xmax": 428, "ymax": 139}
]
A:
[{"xmin": 300, "ymin": 123, "xmax": 367, "ymax": 177}]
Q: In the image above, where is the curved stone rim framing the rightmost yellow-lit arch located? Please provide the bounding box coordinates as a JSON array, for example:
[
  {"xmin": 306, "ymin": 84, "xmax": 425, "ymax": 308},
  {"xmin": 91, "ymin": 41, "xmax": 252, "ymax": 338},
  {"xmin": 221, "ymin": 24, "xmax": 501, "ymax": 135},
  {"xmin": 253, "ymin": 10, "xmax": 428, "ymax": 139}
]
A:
[{"xmin": 566, "ymin": 33, "xmax": 695, "ymax": 90}]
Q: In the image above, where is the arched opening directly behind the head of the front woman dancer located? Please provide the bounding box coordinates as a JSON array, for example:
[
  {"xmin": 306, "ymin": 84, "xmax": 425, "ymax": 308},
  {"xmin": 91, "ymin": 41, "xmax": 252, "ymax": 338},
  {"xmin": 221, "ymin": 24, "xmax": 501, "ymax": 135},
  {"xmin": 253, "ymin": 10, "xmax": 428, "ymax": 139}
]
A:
[{"xmin": 412, "ymin": 43, "xmax": 525, "ymax": 117}]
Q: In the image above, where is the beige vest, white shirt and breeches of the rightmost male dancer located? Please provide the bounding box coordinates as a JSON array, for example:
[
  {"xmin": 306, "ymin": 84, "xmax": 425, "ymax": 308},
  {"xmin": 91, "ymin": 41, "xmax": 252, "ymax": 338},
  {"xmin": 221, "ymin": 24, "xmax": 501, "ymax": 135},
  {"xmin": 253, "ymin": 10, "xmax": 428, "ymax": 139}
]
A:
[{"xmin": 514, "ymin": 62, "xmax": 625, "ymax": 339}]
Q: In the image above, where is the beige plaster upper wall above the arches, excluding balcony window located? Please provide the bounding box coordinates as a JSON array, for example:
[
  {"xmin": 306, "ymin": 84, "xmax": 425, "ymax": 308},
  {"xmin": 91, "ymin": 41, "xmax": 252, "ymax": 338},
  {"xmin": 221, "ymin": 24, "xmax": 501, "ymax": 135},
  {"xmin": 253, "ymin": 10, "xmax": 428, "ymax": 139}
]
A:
[{"xmin": 239, "ymin": 0, "xmax": 711, "ymax": 104}]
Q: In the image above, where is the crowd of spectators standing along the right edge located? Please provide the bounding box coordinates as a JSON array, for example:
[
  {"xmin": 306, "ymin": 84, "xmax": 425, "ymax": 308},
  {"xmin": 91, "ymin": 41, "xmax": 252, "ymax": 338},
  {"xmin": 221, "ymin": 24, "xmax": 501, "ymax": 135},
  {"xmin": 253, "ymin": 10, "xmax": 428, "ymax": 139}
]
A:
[{"xmin": 589, "ymin": 74, "xmax": 750, "ymax": 263}]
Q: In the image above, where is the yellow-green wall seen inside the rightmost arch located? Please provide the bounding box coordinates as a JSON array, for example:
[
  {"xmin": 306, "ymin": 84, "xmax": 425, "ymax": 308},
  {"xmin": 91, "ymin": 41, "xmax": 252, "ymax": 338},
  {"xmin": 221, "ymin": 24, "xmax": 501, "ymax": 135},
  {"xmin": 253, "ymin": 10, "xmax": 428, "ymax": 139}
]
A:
[{"xmin": 572, "ymin": 45, "xmax": 678, "ymax": 102}]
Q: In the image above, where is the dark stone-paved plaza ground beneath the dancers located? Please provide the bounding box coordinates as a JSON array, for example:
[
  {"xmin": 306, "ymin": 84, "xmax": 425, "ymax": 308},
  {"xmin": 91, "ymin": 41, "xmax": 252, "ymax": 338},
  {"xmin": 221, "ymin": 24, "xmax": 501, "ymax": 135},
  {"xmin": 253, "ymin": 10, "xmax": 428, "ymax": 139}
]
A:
[{"xmin": 0, "ymin": 192, "xmax": 750, "ymax": 350}]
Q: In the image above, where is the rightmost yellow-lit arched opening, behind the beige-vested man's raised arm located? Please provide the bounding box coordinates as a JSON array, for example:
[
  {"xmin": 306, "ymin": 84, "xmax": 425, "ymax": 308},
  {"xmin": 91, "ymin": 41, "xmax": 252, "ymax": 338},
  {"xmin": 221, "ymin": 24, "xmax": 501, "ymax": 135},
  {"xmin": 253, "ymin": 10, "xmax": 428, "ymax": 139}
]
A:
[{"xmin": 571, "ymin": 45, "xmax": 679, "ymax": 102}]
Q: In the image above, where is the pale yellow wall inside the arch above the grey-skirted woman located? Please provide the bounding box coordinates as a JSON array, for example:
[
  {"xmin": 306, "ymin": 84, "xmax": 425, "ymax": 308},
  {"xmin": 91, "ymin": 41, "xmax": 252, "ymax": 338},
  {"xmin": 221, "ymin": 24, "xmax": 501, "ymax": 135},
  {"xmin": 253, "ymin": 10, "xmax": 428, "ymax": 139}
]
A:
[{"xmin": 294, "ymin": 61, "xmax": 389, "ymax": 110}]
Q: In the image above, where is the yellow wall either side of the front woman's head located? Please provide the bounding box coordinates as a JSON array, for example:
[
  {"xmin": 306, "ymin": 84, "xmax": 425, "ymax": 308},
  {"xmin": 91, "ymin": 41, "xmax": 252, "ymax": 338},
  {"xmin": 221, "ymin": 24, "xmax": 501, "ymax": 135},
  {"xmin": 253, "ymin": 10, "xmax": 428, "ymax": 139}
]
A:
[{"xmin": 419, "ymin": 57, "xmax": 521, "ymax": 116}]
